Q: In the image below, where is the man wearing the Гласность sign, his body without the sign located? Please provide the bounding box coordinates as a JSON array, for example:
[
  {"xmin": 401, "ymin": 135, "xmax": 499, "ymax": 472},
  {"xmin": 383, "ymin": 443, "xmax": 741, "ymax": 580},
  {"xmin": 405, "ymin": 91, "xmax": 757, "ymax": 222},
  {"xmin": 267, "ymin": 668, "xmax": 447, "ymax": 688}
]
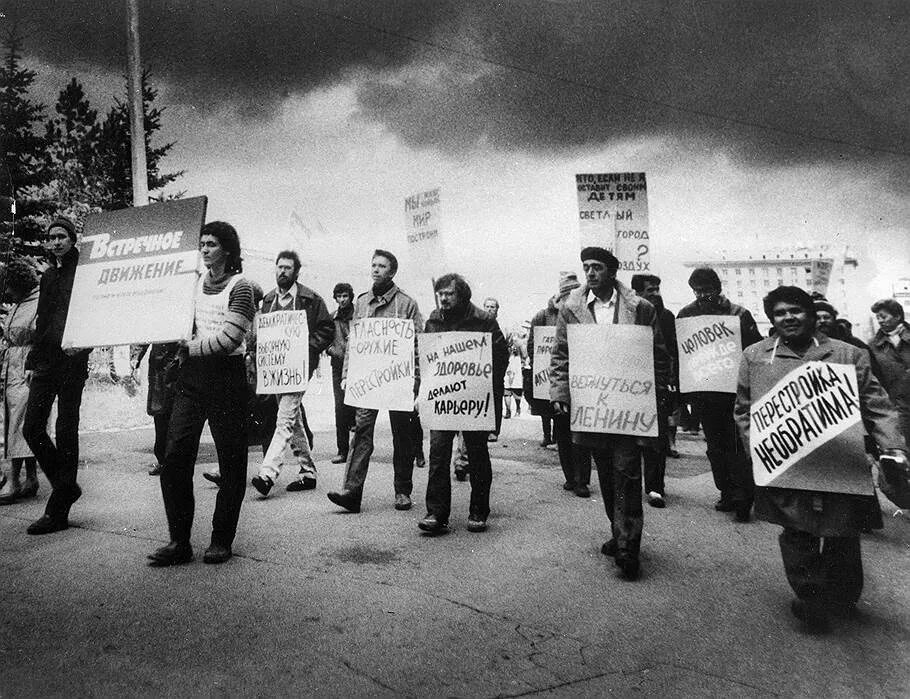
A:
[{"xmin": 326, "ymin": 250, "xmax": 423, "ymax": 512}]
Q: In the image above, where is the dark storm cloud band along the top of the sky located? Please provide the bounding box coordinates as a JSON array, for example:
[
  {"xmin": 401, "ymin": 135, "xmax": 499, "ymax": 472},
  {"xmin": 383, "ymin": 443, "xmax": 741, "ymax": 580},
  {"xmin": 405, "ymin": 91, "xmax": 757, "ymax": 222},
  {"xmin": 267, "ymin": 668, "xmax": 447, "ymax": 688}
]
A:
[{"xmin": 7, "ymin": 0, "xmax": 910, "ymax": 164}]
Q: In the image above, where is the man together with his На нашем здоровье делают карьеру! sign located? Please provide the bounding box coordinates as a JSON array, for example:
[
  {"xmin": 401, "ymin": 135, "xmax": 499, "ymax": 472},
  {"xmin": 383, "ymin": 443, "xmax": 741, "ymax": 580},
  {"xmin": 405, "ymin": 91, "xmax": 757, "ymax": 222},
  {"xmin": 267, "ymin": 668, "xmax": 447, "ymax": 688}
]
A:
[{"xmin": 417, "ymin": 274, "xmax": 509, "ymax": 534}]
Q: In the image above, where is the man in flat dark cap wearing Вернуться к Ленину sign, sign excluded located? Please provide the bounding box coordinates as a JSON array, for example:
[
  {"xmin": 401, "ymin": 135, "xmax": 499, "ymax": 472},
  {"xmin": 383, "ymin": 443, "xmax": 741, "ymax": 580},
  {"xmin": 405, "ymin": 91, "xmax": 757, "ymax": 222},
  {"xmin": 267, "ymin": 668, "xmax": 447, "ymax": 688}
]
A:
[{"xmin": 550, "ymin": 247, "xmax": 670, "ymax": 580}]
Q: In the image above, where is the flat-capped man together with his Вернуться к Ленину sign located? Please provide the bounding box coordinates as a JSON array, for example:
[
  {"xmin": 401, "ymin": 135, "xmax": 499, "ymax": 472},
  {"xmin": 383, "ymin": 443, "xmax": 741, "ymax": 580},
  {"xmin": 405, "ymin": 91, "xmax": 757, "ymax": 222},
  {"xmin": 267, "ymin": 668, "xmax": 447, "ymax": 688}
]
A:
[{"xmin": 550, "ymin": 247, "xmax": 669, "ymax": 580}]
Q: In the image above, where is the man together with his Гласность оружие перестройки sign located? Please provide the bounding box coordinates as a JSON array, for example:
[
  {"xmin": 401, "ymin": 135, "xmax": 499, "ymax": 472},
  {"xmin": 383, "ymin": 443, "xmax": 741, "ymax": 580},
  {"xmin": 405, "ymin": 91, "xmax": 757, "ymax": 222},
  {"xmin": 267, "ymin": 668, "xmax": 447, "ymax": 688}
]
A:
[{"xmin": 327, "ymin": 250, "xmax": 423, "ymax": 512}]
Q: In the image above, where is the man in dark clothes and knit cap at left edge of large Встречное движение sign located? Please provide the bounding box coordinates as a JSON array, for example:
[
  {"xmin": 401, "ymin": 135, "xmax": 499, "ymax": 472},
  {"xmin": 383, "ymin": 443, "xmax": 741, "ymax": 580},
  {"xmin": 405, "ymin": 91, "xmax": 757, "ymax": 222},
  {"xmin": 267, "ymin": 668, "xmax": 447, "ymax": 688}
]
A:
[{"xmin": 22, "ymin": 218, "xmax": 91, "ymax": 534}]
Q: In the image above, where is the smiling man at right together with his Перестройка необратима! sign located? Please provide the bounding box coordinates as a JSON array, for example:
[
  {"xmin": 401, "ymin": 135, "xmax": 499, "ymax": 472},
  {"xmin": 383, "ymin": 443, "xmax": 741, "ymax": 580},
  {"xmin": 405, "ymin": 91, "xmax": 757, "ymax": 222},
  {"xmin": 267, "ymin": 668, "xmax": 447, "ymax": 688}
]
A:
[{"xmin": 735, "ymin": 286, "xmax": 906, "ymax": 628}]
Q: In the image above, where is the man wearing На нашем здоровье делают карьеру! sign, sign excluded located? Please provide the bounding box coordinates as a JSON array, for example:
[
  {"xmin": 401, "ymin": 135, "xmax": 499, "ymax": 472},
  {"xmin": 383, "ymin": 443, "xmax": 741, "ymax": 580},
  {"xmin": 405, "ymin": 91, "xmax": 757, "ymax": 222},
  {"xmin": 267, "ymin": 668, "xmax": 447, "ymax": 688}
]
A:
[{"xmin": 417, "ymin": 274, "xmax": 509, "ymax": 534}]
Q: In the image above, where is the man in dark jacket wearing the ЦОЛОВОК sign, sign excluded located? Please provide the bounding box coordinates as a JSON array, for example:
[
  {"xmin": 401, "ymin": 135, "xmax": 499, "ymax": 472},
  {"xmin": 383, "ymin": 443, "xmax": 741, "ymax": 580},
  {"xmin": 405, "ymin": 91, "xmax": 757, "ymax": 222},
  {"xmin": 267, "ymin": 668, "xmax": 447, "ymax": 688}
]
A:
[{"xmin": 676, "ymin": 267, "xmax": 762, "ymax": 522}]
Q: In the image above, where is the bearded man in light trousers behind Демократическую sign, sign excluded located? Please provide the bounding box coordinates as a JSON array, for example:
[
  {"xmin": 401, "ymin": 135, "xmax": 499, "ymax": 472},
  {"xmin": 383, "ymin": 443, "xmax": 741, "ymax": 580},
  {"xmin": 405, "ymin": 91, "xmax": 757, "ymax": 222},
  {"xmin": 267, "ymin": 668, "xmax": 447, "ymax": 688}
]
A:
[{"xmin": 249, "ymin": 250, "xmax": 335, "ymax": 497}]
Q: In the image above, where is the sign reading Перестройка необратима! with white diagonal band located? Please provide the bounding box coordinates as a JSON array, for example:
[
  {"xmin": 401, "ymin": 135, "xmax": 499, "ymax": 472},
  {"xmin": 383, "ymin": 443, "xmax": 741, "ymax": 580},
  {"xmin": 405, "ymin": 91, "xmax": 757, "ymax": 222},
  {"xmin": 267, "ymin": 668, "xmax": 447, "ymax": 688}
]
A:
[{"xmin": 749, "ymin": 362, "xmax": 872, "ymax": 495}]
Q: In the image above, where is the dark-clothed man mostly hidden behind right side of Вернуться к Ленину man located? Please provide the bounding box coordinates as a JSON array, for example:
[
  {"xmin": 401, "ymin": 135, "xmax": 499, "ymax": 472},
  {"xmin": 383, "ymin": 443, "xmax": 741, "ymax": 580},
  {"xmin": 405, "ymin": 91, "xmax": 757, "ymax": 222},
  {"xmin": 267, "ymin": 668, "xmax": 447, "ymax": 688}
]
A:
[{"xmin": 632, "ymin": 274, "xmax": 679, "ymax": 508}]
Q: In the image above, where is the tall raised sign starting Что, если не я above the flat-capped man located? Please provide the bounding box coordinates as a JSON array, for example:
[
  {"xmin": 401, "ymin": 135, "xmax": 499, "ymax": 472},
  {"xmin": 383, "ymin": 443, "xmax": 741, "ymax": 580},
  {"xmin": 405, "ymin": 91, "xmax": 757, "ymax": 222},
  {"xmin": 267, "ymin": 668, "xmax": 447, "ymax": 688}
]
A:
[{"xmin": 575, "ymin": 172, "xmax": 651, "ymax": 272}]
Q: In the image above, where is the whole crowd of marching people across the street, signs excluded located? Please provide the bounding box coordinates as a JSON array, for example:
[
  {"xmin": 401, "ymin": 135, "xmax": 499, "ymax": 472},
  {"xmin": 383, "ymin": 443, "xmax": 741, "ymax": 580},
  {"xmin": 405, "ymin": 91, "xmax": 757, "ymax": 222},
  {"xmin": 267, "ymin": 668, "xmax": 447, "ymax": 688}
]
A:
[{"xmin": 0, "ymin": 219, "xmax": 910, "ymax": 625}]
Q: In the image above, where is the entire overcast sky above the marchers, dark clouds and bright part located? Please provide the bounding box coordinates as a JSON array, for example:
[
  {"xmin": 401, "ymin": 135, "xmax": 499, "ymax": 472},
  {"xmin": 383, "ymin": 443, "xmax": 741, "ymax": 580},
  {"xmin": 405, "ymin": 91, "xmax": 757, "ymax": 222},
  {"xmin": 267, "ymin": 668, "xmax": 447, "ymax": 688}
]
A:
[{"xmin": 3, "ymin": 0, "xmax": 910, "ymax": 322}]
